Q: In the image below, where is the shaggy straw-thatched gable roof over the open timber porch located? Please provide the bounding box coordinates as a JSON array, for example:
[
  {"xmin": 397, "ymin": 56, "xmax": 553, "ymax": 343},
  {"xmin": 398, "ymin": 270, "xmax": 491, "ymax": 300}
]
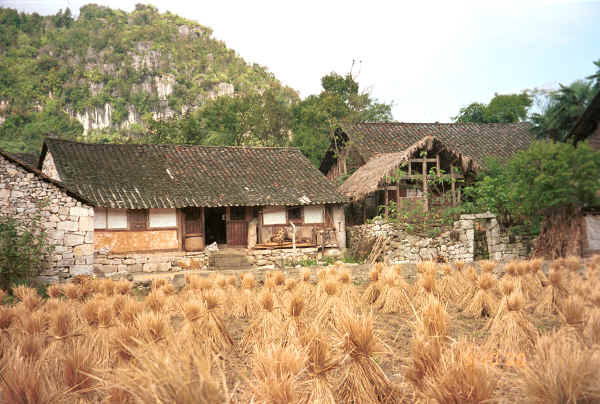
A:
[{"xmin": 338, "ymin": 136, "xmax": 480, "ymax": 200}]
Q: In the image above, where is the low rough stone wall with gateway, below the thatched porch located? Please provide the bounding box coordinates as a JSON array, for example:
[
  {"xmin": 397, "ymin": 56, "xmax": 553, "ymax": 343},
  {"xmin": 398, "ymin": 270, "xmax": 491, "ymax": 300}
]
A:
[{"xmin": 347, "ymin": 213, "xmax": 533, "ymax": 264}]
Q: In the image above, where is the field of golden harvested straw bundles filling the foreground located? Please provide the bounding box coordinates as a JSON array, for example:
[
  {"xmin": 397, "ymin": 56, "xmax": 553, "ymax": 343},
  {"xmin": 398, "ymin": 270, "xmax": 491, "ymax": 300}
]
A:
[{"xmin": 0, "ymin": 257, "xmax": 600, "ymax": 403}]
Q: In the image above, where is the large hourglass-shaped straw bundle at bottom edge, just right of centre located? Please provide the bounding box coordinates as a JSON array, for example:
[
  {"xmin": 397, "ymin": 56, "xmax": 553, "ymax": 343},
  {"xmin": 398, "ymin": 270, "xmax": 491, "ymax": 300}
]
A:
[{"xmin": 336, "ymin": 311, "xmax": 393, "ymax": 403}]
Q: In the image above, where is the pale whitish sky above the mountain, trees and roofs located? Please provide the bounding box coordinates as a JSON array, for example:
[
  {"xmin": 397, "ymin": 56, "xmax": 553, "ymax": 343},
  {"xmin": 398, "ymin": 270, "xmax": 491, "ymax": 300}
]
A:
[{"xmin": 0, "ymin": 0, "xmax": 600, "ymax": 122}]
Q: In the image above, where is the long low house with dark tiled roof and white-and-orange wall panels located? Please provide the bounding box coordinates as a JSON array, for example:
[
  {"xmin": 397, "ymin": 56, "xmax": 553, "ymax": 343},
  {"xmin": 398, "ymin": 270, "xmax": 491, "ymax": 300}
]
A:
[{"xmin": 39, "ymin": 139, "xmax": 346, "ymax": 272}]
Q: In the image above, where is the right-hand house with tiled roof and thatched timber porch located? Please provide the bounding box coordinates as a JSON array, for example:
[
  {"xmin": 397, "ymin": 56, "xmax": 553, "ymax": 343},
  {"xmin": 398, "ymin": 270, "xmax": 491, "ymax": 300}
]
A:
[{"xmin": 320, "ymin": 123, "xmax": 534, "ymax": 224}]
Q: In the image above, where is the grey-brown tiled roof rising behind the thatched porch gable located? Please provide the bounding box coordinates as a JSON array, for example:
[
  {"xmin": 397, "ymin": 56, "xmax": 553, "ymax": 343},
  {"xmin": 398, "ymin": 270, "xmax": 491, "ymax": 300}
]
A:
[{"xmin": 344, "ymin": 122, "xmax": 535, "ymax": 166}]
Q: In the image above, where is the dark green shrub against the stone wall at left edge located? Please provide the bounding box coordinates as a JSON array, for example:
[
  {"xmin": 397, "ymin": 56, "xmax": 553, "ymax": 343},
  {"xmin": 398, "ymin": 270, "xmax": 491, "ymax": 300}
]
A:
[{"xmin": 0, "ymin": 215, "xmax": 51, "ymax": 290}]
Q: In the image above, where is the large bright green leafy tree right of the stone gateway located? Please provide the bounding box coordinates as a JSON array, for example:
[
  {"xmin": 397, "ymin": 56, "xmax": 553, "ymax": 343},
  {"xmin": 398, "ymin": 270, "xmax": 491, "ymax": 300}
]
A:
[{"xmin": 464, "ymin": 140, "xmax": 600, "ymax": 229}]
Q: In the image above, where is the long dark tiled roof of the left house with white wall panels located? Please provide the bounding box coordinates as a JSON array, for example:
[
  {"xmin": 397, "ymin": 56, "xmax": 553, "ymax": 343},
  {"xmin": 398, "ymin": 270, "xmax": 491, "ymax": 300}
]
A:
[{"xmin": 42, "ymin": 139, "xmax": 346, "ymax": 209}]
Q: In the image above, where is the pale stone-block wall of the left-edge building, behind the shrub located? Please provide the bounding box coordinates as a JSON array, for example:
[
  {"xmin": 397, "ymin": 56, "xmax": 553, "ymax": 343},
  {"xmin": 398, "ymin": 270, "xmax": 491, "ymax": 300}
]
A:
[{"xmin": 0, "ymin": 155, "xmax": 94, "ymax": 282}]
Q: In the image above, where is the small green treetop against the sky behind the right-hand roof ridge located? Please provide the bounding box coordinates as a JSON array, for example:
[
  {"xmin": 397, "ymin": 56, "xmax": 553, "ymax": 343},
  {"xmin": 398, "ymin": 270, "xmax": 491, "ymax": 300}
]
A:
[{"xmin": 452, "ymin": 92, "xmax": 532, "ymax": 123}]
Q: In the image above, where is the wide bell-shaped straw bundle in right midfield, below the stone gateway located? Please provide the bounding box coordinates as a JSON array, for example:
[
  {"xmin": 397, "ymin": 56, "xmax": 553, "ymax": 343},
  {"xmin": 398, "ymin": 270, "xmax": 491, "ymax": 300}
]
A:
[{"xmin": 486, "ymin": 291, "xmax": 537, "ymax": 355}]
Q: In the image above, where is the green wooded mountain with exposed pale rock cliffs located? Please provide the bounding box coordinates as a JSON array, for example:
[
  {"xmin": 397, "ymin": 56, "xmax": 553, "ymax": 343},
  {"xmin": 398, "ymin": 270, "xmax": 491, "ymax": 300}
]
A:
[{"xmin": 0, "ymin": 4, "xmax": 298, "ymax": 151}]
